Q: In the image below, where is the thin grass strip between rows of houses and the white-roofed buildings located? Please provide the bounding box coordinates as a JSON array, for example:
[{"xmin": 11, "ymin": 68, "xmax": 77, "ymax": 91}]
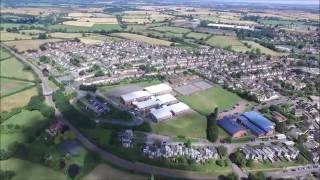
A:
[{"xmin": 98, "ymin": 79, "xmax": 161, "ymax": 94}]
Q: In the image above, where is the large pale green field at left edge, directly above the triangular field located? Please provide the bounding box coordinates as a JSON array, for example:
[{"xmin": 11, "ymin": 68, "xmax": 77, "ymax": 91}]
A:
[{"xmin": 0, "ymin": 57, "xmax": 34, "ymax": 80}]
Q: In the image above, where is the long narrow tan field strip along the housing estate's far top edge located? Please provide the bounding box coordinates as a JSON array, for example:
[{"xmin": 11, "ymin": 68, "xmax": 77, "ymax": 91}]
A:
[{"xmin": 111, "ymin": 33, "xmax": 172, "ymax": 46}]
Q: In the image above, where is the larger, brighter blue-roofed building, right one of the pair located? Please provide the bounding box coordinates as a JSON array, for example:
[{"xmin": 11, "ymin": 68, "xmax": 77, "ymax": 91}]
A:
[{"xmin": 241, "ymin": 111, "xmax": 275, "ymax": 133}]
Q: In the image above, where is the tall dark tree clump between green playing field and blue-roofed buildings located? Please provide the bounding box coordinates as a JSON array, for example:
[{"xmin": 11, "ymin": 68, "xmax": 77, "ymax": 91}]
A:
[{"xmin": 207, "ymin": 108, "xmax": 219, "ymax": 142}]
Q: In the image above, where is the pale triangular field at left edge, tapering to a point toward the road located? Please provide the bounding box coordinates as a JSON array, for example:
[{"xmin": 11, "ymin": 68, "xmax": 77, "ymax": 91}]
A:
[{"xmin": 0, "ymin": 78, "xmax": 34, "ymax": 97}]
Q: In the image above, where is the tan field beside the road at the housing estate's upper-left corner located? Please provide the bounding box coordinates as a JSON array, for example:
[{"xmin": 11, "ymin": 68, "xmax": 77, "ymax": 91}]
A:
[{"xmin": 4, "ymin": 39, "xmax": 61, "ymax": 52}]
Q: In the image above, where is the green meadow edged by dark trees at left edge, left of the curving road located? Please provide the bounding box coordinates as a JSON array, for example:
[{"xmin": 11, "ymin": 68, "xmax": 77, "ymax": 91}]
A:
[{"xmin": 1, "ymin": 110, "xmax": 44, "ymax": 150}]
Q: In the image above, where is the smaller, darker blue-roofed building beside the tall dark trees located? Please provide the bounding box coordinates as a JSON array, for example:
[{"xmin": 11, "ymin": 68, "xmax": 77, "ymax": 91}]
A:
[{"xmin": 218, "ymin": 116, "xmax": 246, "ymax": 137}]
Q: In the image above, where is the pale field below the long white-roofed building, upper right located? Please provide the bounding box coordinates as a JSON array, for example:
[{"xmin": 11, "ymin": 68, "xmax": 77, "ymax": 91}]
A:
[{"xmin": 206, "ymin": 36, "xmax": 250, "ymax": 52}]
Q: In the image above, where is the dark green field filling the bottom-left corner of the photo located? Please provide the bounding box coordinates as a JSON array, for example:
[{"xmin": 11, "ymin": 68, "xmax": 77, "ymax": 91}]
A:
[{"xmin": 0, "ymin": 158, "xmax": 67, "ymax": 180}]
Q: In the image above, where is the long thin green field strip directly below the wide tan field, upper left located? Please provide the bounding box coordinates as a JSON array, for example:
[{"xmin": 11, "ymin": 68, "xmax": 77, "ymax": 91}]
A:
[{"xmin": 48, "ymin": 24, "xmax": 121, "ymax": 32}]
